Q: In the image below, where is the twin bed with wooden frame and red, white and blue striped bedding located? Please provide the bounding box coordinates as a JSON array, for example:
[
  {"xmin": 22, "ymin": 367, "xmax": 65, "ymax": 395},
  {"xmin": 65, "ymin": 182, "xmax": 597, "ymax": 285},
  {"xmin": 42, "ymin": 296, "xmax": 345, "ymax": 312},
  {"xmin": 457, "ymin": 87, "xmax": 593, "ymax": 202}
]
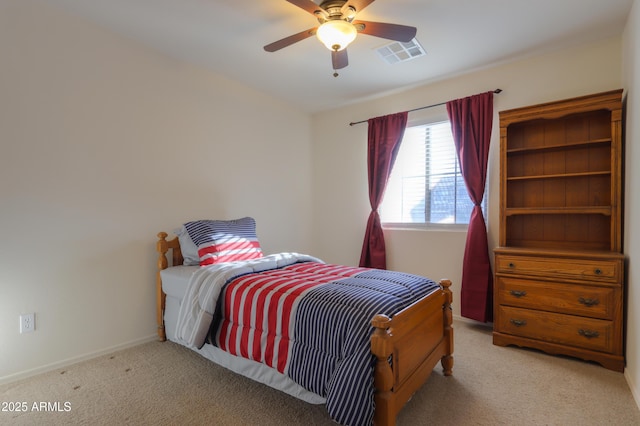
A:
[{"xmin": 157, "ymin": 218, "xmax": 453, "ymax": 425}]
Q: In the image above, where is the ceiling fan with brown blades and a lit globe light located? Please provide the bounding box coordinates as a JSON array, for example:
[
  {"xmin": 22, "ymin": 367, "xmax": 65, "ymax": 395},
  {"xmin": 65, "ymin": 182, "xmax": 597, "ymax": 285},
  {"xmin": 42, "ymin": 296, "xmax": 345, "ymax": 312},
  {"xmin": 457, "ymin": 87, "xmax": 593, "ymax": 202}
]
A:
[{"xmin": 264, "ymin": 0, "xmax": 417, "ymax": 77}]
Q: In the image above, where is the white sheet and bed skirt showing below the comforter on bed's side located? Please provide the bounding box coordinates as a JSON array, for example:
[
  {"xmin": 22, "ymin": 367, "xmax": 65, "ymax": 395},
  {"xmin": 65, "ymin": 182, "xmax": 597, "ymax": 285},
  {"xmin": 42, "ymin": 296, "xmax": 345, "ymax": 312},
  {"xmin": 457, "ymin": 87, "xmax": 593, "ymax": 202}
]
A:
[{"xmin": 160, "ymin": 266, "xmax": 326, "ymax": 404}]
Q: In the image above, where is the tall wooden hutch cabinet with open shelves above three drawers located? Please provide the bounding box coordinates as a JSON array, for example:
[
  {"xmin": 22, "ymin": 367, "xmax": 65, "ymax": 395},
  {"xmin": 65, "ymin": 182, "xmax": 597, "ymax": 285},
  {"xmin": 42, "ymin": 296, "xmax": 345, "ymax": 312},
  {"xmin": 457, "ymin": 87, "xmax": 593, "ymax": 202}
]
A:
[{"xmin": 493, "ymin": 90, "xmax": 625, "ymax": 371}]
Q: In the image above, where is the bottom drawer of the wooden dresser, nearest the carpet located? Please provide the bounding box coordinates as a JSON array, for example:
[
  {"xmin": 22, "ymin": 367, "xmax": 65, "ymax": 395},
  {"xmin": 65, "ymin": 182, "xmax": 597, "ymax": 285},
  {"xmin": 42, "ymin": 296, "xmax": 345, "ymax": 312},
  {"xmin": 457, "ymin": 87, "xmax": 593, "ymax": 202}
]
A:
[{"xmin": 495, "ymin": 306, "xmax": 615, "ymax": 352}]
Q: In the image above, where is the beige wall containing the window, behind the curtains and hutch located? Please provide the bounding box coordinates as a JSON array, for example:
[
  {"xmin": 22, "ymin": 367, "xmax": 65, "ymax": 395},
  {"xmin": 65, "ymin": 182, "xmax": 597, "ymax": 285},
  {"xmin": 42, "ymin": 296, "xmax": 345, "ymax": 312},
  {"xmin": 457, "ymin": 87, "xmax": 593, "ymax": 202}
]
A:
[{"xmin": 313, "ymin": 38, "xmax": 622, "ymax": 322}]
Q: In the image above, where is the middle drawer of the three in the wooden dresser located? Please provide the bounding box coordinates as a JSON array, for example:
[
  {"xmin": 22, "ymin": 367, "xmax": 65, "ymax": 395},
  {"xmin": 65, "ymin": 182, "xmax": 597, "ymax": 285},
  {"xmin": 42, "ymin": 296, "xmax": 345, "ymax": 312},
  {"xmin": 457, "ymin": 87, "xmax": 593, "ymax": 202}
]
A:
[{"xmin": 496, "ymin": 276, "xmax": 621, "ymax": 320}]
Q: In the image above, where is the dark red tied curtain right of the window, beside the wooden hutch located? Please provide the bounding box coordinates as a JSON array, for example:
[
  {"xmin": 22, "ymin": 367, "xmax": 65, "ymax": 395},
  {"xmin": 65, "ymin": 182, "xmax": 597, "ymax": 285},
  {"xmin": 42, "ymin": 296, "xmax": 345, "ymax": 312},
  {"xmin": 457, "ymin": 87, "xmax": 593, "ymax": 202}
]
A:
[{"xmin": 447, "ymin": 92, "xmax": 493, "ymax": 322}]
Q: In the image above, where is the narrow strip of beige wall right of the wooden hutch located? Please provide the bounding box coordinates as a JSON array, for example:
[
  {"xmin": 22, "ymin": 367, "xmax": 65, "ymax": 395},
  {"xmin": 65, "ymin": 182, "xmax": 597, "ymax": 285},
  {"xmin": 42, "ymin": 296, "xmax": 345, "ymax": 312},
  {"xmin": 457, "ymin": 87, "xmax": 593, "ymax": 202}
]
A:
[{"xmin": 623, "ymin": 0, "xmax": 640, "ymax": 406}]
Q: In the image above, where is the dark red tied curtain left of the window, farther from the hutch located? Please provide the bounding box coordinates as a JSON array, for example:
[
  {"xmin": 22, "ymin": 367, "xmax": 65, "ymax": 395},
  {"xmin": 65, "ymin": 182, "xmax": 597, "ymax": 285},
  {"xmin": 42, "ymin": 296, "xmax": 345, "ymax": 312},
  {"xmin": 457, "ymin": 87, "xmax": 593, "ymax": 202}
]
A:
[{"xmin": 360, "ymin": 112, "xmax": 408, "ymax": 269}]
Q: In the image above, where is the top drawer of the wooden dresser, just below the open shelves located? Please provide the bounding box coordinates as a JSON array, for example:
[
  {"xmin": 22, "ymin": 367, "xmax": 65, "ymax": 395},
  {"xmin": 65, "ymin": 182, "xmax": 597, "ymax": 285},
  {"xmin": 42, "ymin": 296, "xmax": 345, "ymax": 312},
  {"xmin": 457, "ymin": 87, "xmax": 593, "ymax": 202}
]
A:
[{"xmin": 496, "ymin": 255, "xmax": 621, "ymax": 283}]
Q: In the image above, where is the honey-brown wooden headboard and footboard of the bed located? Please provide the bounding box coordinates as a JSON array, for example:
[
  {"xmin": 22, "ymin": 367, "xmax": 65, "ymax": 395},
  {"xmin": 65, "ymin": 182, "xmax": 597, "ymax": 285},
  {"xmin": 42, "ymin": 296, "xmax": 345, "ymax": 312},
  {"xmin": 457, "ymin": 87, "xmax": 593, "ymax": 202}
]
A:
[{"xmin": 156, "ymin": 232, "xmax": 453, "ymax": 425}]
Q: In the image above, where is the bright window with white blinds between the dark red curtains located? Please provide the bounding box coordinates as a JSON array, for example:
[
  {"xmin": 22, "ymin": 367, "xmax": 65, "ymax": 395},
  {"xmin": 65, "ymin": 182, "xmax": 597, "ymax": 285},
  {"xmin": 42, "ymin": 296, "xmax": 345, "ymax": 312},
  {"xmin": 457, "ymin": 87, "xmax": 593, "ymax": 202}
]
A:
[{"xmin": 380, "ymin": 121, "xmax": 486, "ymax": 224}]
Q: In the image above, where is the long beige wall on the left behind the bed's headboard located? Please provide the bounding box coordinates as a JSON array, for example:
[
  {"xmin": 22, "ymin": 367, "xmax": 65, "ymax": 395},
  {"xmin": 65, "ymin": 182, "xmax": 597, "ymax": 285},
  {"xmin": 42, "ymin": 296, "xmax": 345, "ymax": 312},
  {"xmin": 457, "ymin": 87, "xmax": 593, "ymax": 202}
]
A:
[{"xmin": 0, "ymin": 0, "xmax": 311, "ymax": 381}]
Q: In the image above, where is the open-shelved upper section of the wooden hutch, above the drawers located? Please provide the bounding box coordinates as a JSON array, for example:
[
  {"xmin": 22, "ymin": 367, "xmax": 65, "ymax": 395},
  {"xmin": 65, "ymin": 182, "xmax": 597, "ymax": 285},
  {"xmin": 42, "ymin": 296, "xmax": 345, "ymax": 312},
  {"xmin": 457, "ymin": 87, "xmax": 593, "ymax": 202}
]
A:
[{"xmin": 499, "ymin": 90, "xmax": 622, "ymax": 252}]
